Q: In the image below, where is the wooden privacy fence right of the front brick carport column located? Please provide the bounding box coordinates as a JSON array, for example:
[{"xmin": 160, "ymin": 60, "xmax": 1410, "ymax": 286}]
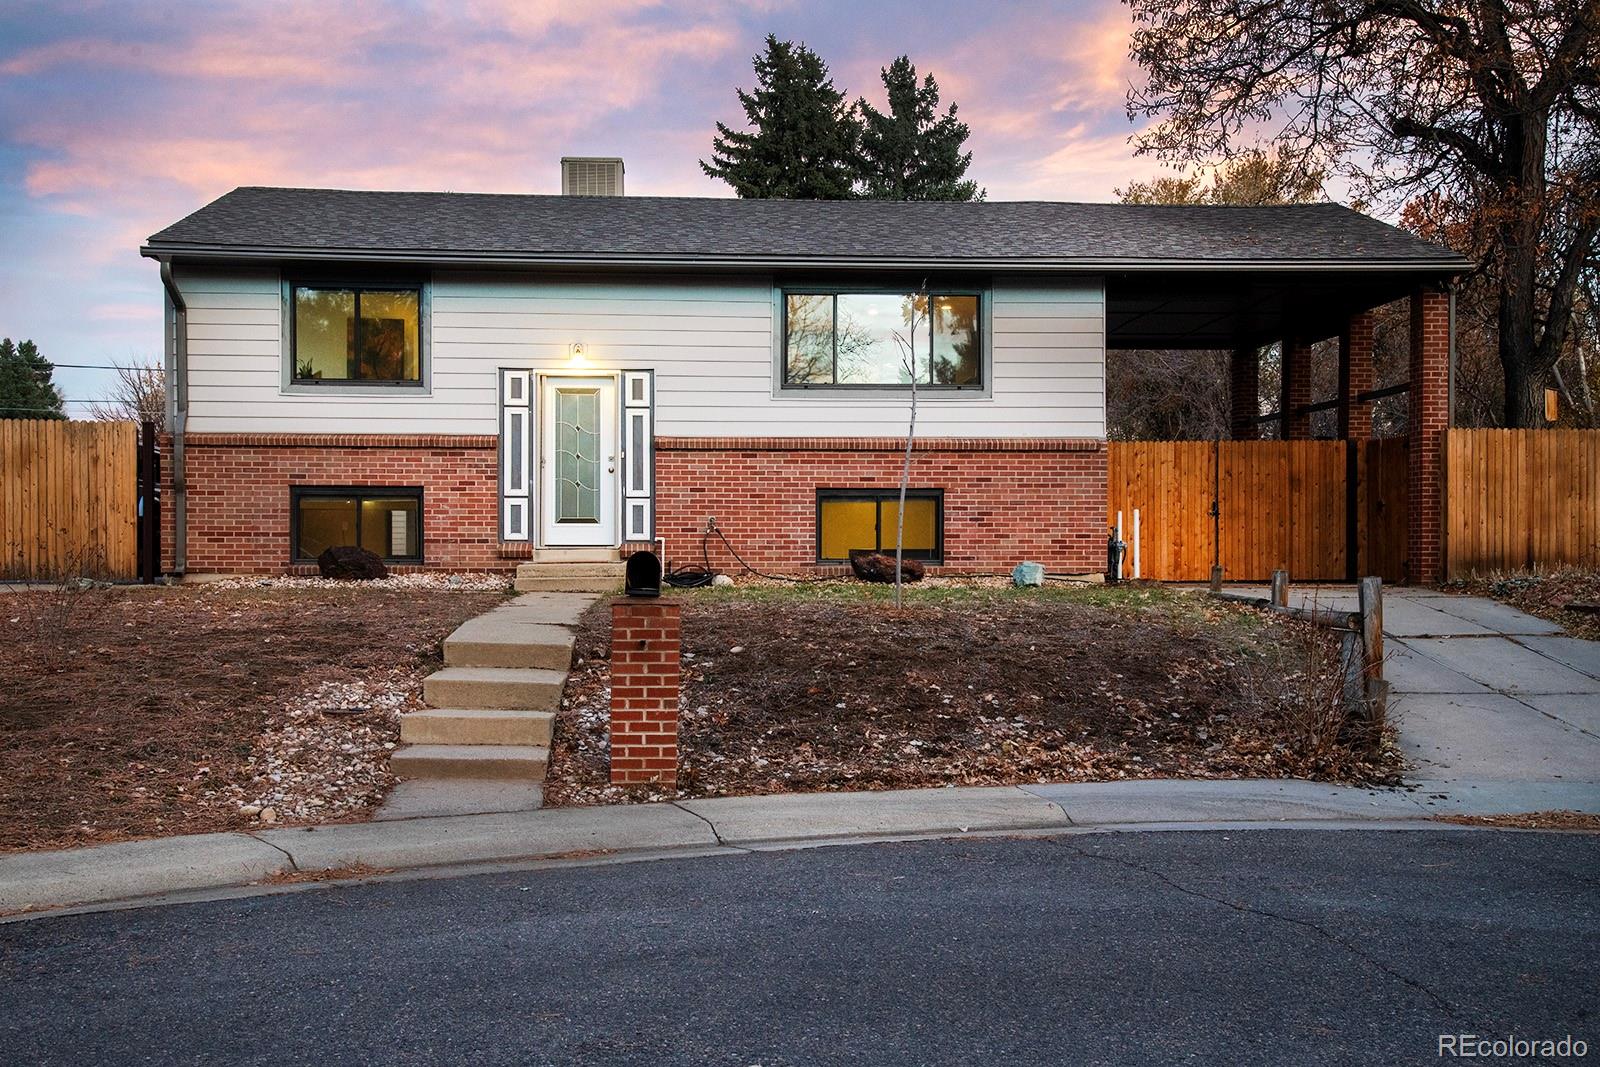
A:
[{"xmin": 1445, "ymin": 430, "xmax": 1600, "ymax": 577}]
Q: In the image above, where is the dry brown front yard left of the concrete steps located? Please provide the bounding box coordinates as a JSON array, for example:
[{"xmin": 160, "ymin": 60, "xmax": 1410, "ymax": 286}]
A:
[{"xmin": 0, "ymin": 585, "xmax": 502, "ymax": 851}]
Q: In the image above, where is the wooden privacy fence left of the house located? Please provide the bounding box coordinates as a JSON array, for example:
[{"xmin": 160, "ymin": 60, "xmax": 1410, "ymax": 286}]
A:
[{"xmin": 0, "ymin": 419, "xmax": 139, "ymax": 581}]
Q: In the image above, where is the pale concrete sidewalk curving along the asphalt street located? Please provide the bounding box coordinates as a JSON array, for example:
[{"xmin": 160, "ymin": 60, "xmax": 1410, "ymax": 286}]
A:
[{"xmin": 0, "ymin": 781, "xmax": 1600, "ymax": 913}]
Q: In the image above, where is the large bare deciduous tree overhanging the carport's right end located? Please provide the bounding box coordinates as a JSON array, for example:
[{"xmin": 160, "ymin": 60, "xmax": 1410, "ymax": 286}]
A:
[{"xmin": 1126, "ymin": 0, "xmax": 1600, "ymax": 426}]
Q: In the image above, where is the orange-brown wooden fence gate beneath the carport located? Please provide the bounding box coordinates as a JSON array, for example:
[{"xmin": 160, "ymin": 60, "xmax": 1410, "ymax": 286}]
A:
[{"xmin": 1107, "ymin": 438, "xmax": 1408, "ymax": 581}]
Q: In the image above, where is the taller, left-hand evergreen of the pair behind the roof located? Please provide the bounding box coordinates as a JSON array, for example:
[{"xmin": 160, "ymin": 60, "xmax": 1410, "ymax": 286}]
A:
[{"xmin": 701, "ymin": 34, "xmax": 856, "ymax": 200}]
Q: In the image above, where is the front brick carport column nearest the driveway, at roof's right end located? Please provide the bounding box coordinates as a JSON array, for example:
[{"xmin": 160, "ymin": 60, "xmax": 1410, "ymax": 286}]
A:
[{"xmin": 1406, "ymin": 286, "xmax": 1450, "ymax": 585}]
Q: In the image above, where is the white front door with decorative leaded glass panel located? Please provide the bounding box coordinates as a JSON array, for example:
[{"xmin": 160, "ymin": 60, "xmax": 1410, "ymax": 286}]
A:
[{"xmin": 539, "ymin": 378, "xmax": 621, "ymax": 547}]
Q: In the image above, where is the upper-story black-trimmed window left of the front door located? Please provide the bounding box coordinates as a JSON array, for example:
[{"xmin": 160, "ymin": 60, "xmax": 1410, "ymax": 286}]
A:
[{"xmin": 290, "ymin": 283, "xmax": 422, "ymax": 386}]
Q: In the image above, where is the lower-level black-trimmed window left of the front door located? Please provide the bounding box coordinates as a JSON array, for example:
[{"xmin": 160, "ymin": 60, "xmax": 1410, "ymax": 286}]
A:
[{"xmin": 290, "ymin": 485, "xmax": 422, "ymax": 563}]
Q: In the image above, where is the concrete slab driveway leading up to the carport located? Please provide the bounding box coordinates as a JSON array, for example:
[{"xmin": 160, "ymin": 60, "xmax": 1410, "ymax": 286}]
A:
[{"xmin": 1241, "ymin": 585, "xmax": 1600, "ymax": 811}]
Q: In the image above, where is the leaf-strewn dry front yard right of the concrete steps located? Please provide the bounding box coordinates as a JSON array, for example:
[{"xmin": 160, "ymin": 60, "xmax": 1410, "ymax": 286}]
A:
[{"xmin": 546, "ymin": 582, "xmax": 1398, "ymax": 803}]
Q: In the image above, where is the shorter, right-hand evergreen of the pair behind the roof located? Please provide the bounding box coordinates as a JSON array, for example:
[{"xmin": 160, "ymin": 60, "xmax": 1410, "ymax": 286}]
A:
[{"xmin": 856, "ymin": 56, "xmax": 986, "ymax": 200}]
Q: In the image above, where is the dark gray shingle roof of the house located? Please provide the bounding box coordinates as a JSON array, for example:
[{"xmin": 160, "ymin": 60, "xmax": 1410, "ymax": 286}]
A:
[{"xmin": 144, "ymin": 187, "xmax": 1467, "ymax": 272}]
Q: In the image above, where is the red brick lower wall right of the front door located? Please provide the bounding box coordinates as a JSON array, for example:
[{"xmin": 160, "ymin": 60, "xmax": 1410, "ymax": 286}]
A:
[{"xmin": 656, "ymin": 438, "xmax": 1106, "ymax": 574}]
